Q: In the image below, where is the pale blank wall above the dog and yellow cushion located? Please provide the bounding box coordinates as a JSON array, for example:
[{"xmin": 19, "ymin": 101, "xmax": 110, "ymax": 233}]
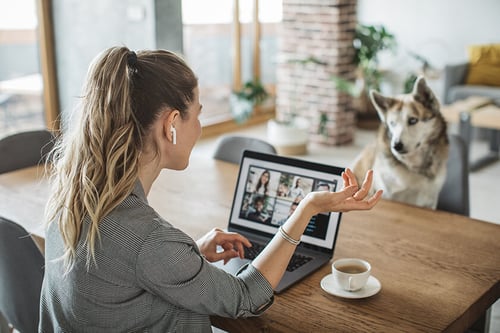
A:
[{"xmin": 358, "ymin": 0, "xmax": 500, "ymax": 96}]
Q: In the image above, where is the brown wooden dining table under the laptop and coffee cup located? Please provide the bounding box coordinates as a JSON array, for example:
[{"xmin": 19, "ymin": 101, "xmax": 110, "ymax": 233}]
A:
[{"xmin": 0, "ymin": 156, "xmax": 500, "ymax": 332}]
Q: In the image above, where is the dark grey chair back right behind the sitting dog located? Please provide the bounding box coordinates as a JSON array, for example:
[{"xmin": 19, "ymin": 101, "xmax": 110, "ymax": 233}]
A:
[{"xmin": 437, "ymin": 134, "xmax": 470, "ymax": 216}]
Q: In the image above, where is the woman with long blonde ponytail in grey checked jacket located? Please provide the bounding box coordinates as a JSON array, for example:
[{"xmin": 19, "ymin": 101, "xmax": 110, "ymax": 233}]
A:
[{"xmin": 40, "ymin": 47, "xmax": 380, "ymax": 332}]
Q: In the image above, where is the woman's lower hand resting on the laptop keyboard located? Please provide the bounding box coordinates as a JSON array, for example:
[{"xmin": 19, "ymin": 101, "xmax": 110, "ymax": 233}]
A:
[{"xmin": 196, "ymin": 228, "xmax": 252, "ymax": 264}]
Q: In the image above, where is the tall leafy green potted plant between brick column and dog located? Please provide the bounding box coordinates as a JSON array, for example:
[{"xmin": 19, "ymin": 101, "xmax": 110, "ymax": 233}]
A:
[{"xmin": 331, "ymin": 24, "xmax": 397, "ymax": 127}]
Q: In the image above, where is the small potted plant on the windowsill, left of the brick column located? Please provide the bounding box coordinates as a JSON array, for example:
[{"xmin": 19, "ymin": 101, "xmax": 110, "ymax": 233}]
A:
[{"xmin": 230, "ymin": 79, "xmax": 269, "ymax": 124}]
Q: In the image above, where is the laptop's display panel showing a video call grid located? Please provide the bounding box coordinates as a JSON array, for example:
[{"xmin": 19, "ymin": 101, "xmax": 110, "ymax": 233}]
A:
[{"xmin": 230, "ymin": 150, "xmax": 343, "ymax": 250}]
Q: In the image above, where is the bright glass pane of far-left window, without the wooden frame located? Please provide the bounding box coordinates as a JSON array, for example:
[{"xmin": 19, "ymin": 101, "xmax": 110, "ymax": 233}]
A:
[{"xmin": 0, "ymin": 0, "xmax": 45, "ymax": 136}]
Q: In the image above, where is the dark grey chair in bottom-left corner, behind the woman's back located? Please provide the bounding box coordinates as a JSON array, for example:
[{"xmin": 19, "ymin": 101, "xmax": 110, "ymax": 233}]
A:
[{"xmin": 0, "ymin": 217, "xmax": 44, "ymax": 332}]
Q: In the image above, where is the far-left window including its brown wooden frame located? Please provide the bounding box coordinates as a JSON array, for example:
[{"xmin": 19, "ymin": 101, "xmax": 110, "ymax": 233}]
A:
[{"xmin": 0, "ymin": 0, "xmax": 59, "ymax": 137}]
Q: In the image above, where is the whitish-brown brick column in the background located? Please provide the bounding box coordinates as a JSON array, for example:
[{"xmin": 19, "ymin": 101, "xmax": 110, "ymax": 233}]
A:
[{"xmin": 276, "ymin": 0, "xmax": 357, "ymax": 145}]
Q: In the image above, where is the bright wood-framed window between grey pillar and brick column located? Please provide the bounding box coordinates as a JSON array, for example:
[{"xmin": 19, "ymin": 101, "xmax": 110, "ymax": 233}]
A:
[{"xmin": 182, "ymin": 0, "xmax": 282, "ymax": 127}]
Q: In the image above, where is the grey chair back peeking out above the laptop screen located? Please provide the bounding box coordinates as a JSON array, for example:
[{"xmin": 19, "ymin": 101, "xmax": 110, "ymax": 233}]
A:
[{"xmin": 213, "ymin": 135, "xmax": 276, "ymax": 164}]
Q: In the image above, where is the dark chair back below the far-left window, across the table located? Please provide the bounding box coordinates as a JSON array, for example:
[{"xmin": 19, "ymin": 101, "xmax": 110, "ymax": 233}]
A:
[{"xmin": 0, "ymin": 130, "xmax": 54, "ymax": 174}]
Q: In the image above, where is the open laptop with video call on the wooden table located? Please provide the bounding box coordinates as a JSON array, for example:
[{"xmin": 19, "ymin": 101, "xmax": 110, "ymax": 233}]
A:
[{"xmin": 214, "ymin": 150, "xmax": 344, "ymax": 293}]
